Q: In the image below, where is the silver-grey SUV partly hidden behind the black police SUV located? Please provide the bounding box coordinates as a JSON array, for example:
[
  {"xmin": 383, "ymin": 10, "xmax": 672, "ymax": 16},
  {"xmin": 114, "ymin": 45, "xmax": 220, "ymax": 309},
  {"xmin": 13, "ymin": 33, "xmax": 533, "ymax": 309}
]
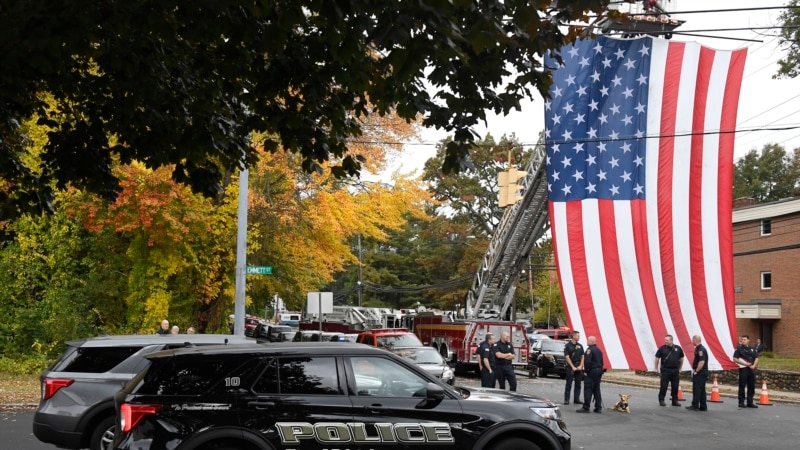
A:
[{"xmin": 33, "ymin": 334, "xmax": 255, "ymax": 450}]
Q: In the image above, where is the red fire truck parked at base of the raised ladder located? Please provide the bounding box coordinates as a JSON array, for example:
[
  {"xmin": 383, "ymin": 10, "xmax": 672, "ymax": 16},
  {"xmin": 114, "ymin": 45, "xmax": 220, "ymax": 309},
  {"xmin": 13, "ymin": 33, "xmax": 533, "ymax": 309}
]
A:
[{"xmin": 413, "ymin": 312, "xmax": 530, "ymax": 372}]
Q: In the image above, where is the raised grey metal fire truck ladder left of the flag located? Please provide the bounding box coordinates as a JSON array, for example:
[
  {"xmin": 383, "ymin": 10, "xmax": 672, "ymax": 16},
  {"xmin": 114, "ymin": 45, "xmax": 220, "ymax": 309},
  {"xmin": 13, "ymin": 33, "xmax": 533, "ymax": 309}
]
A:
[{"xmin": 466, "ymin": 145, "xmax": 550, "ymax": 319}]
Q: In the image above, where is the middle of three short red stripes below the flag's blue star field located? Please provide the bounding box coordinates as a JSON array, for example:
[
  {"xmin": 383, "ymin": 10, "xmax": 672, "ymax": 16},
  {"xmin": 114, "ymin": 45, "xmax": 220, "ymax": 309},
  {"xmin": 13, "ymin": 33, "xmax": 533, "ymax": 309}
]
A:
[{"xmin": 598, "ymin": 200, "xmax": 646, "ymax": 368}]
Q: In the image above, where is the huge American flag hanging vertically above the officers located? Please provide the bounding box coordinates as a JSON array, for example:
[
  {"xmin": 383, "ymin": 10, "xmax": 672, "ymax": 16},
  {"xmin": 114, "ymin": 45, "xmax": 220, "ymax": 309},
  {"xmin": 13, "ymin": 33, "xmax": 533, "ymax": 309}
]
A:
[{"xmin": 545, "ymin": 36, "xmax": 746, "ymax": 370}]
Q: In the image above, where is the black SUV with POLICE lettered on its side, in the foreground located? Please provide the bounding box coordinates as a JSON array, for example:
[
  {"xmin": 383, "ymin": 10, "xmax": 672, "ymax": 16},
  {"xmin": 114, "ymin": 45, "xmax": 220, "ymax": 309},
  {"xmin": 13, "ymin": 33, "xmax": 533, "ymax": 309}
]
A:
[{"xmin": 114, "ymin": 342, "xmax": 570, "ymax": 450}]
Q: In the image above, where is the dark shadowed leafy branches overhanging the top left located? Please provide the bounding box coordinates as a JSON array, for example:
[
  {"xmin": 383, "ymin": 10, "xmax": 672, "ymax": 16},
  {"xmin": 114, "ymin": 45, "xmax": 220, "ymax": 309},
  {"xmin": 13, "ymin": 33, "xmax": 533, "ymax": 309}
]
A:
[{"xmin": 0, "ymin": 0, "xmax": 608, "ymax": 217}]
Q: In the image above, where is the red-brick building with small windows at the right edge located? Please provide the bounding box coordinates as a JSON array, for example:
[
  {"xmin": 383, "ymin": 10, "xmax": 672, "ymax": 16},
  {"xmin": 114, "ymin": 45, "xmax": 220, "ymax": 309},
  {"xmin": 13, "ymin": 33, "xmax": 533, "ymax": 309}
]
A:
[{"xmin": 733, "ymin": 198, "xmax": 800, "ymax": 357}]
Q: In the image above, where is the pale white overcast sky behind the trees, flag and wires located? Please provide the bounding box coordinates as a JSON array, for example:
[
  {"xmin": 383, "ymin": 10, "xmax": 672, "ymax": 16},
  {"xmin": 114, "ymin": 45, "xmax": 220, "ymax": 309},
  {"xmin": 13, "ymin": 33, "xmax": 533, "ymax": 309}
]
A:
[{"xmin": 392, "ymin": 0, "xmax": 800, "ymax": 176}]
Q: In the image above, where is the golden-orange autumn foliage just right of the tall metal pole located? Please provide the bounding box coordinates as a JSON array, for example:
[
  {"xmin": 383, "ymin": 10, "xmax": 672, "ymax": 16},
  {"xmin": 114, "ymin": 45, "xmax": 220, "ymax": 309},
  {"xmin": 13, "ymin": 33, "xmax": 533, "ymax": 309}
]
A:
[{"xmin": 248, "ymin": 115, "xmax": 429, "ymax": 310}]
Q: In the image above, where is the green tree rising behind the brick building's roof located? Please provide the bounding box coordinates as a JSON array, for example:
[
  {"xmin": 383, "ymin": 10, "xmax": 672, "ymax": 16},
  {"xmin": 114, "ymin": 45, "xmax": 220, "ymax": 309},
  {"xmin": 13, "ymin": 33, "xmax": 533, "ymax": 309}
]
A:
[{"xmin": 733, "ymin": 144, "xmax": 800, "ymax": 203}]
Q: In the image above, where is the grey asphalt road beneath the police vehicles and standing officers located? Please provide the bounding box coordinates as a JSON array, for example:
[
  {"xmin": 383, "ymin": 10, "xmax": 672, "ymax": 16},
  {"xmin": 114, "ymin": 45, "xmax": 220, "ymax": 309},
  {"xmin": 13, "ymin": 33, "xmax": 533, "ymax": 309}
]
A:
[{"xmin": 7, "ymin": 373, "xmax": 800, "ymax": 450}]
